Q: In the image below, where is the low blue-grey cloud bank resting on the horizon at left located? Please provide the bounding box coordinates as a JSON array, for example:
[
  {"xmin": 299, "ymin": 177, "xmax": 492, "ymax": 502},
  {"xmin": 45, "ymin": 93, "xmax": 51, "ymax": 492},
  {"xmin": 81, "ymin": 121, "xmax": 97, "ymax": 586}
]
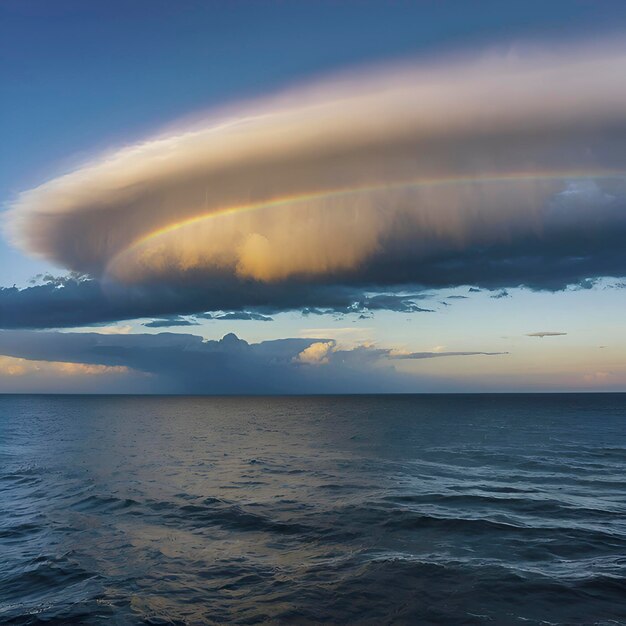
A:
[{"xmin": 0, "ymin": 330, "xmax": 502, "ymax": 394}]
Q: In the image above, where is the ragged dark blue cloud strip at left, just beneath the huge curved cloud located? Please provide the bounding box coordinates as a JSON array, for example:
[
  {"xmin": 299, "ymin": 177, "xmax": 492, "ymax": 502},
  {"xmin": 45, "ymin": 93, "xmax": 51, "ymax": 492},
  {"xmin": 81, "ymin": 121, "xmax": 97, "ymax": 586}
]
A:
[{"xmin": 0, "ymin": 276, "xmax": 428, "ymax": 328}]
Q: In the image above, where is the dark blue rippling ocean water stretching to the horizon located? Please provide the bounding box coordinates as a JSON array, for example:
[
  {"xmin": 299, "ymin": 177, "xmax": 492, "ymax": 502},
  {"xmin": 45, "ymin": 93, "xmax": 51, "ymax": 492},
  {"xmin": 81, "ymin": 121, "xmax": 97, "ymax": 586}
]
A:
[{"xmin": 0, "ymin": 394, "xmax": 626, "ymax": 625}]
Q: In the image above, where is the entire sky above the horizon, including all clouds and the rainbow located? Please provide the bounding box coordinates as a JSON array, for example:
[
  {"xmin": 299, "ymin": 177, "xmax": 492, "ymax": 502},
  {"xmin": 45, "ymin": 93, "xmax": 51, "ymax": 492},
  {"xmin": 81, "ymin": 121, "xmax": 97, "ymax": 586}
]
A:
[{"xmin": 0, "ymin": 0, "xmax": 626, "ymax": 394}]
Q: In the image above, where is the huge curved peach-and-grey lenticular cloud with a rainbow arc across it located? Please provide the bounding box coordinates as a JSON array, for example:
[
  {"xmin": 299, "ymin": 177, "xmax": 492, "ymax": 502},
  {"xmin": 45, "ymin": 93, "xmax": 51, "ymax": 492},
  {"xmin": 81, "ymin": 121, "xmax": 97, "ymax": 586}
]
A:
[{"xmin": 8, "ymin": 37, "xmax": 626, "ymax": 293}]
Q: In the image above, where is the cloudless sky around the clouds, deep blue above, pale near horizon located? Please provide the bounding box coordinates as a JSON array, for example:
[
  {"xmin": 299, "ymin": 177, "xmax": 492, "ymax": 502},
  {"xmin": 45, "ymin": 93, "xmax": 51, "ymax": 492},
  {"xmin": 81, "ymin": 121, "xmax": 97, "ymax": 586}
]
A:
[{"xmin": 0, "ymin": 0, "xmax": 626, "ymax": 391}]
